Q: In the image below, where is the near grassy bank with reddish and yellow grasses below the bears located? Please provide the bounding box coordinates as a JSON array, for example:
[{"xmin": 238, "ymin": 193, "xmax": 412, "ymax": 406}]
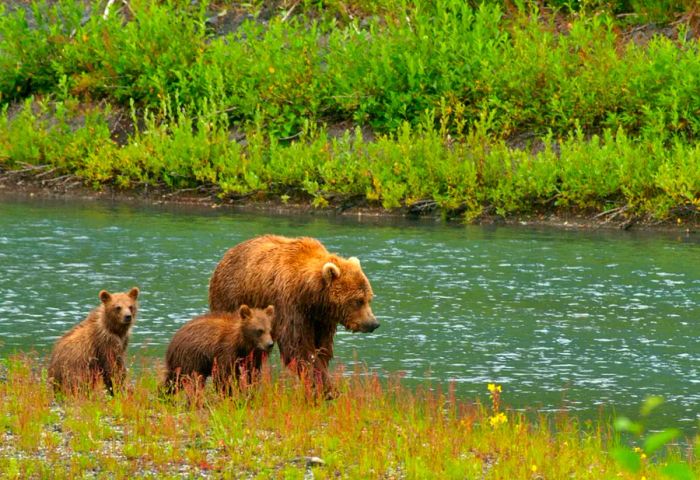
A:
[{"xmin": 0, "ymin": 356, "xmax": 700, "ymax": 479}]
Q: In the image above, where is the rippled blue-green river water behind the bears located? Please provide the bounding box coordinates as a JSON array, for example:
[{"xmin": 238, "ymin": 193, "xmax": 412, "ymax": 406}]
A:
[{"xmin": 0, "ymin": 199, "xmax": 700, "ymax": 429}]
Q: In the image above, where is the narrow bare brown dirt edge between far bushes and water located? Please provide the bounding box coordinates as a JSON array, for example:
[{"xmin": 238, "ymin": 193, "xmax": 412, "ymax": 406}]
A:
[{"xmin": 0, "ymin": 166, "xmax": 700, "ymax": 235}]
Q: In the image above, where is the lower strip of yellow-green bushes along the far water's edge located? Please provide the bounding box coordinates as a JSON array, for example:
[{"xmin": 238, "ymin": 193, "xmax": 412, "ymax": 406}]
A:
[{"xmin": 0, "ymin": 101, "xmax": 700, "ymax": 218}]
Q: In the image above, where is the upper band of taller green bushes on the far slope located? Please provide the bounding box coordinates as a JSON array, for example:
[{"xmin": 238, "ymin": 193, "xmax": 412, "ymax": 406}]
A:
[{"xmin": 0, "ymin": 0, "xmax": 700, "ymax": 139}]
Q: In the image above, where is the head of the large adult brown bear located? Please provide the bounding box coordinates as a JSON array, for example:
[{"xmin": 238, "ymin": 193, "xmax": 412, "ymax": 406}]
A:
[{"xmin": 321, "ymin": 257, "xmax": 379, "ymax": 332}]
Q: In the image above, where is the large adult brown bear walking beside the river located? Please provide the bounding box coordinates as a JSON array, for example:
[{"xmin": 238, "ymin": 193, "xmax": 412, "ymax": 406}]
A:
[{"xmin": 209, "ymin": 235, "xmax": 379, "ymax": 390}]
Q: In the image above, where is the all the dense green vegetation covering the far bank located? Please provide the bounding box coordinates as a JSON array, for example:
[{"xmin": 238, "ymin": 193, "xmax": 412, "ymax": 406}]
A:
[{"xmin": 0, "ymin": 0, "xmax": 700, "ymax": 220}]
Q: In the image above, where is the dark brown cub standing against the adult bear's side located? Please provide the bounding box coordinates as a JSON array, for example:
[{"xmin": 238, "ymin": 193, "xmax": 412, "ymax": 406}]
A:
[{"xmin": 163, "ymin": 305, "xmax": 275, "ymax": 395}]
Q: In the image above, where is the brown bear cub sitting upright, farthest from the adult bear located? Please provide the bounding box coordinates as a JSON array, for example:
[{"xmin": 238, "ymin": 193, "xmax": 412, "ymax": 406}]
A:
[{"xmin": 48, "ymin": 287, "xmax": 139, "ymax": 394}]
